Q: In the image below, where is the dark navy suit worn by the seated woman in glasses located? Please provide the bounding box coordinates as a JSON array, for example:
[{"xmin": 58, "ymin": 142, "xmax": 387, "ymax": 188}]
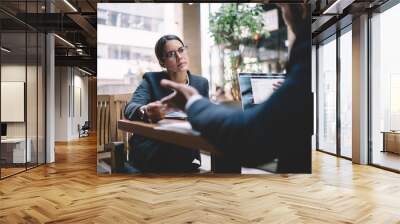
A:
[{"xmin": 124, "ymin": 72, "xmax": 208, "ymax": 172}]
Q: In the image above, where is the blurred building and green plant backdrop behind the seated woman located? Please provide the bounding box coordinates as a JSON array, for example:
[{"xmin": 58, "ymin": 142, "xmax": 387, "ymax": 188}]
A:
[{"xmin": 97, "ymin": 3, "xmax": 287, "ymax": 99}]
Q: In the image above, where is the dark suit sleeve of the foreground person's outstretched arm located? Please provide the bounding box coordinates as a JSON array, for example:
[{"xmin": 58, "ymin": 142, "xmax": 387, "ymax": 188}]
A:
[{"xmin": 187, "ymin": 78, "xmax": 312, "ymax": 169}]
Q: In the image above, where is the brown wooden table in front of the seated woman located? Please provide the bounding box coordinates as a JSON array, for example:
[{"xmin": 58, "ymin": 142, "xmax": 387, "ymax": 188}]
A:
[{"xmin": 118, "ymin": 119, "xmax": 241, "ymax": 173}]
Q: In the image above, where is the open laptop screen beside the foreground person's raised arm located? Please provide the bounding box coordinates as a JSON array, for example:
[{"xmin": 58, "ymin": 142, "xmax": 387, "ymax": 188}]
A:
[{"xmin": 239, "ymin": 73, "xmax": 285, "ymax": 110}]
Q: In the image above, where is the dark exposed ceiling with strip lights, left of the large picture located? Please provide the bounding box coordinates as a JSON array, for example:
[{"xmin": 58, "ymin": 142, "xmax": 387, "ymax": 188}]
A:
[{"xmin": 0, "ymin": 0, "xmax": 100, "ymax": 74}]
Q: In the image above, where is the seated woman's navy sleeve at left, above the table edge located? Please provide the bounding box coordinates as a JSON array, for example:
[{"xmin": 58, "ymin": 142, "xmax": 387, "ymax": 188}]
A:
[{"xmin": 124, "ymin": 79, "xmax": 151, "ymax": 120}]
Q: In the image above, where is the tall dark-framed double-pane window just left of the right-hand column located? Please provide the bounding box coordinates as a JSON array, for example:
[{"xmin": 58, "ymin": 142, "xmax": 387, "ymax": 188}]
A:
[{"xmin": 316, "ymin": 25, "xmax": 353, "ymax": 158}]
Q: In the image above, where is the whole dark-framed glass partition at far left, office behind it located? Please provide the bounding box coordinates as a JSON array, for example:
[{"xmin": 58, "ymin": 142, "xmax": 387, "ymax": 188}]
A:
[{"xmin": 0, "ymin": 1, "xmax": 46, "ymax": 179}]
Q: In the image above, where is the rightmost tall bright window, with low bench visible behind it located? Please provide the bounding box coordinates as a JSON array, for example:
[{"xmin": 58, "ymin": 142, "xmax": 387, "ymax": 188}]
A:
[{"xmin": 370, "ymin": 1, "xmax": 400, "ymax": 170}]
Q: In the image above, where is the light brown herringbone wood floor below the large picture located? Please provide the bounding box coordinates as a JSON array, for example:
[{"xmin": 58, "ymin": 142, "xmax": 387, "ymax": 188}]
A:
[{"xmin": 0, "ymin": 135, "xmax": 400, "ymax": 224}]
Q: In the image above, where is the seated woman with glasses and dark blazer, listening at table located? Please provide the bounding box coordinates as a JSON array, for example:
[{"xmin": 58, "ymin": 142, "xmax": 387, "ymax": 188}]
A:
[{"xmin": 125, "ymin": 35, "xmax": 208, "ymax": 173}]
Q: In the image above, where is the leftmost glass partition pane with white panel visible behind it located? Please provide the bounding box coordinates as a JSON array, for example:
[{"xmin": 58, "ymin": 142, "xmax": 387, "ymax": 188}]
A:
[{"xmin": 0, "ymin": 32, "xmax": 27, "ymax": 177}]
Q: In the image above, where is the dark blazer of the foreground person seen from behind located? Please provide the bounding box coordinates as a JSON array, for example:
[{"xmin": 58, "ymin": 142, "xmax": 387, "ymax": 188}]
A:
[{"xmin": 187, "ymin": 38, "xmax": 313, "ymax": 173}]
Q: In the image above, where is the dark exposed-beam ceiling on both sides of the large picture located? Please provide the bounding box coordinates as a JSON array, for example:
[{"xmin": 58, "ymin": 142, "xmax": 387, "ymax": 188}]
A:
[{"xmin": 0, "ymin": 0, "xmax": 394, "ymax": 73}]
